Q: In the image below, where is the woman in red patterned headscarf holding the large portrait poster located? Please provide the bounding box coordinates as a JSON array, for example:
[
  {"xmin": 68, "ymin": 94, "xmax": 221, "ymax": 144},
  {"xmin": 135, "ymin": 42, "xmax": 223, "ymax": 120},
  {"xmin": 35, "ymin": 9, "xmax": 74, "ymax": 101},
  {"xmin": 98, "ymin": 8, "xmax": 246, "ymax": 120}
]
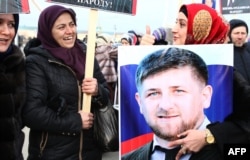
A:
[{"xmin": 143, "ymin": 4, "xmax": 250, "ymax": 159}]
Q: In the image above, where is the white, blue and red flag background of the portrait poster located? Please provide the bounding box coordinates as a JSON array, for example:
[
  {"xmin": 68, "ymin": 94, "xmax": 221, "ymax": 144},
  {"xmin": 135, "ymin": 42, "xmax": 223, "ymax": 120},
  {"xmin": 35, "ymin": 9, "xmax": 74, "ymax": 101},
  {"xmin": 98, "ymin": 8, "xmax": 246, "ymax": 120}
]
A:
[{"xmin": 118, "ymin": 44, "xmax": 233, "ymax": 156}]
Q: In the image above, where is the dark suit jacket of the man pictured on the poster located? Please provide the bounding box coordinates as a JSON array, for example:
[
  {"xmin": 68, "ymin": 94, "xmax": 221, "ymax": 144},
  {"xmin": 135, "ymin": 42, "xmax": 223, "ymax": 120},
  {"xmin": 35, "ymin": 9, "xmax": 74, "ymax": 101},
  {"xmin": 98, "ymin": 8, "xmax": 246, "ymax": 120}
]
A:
[{"xmin": 122, "ymin": 142, "xmax": 222, "ymax": 160}]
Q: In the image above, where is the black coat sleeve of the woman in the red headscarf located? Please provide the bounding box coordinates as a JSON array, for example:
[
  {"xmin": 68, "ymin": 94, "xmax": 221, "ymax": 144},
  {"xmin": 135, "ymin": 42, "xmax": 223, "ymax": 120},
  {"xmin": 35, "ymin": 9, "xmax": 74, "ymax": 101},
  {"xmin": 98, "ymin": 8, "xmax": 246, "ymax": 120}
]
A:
[{"xmin": 207, "ymin": 71, "xmax": 250, "ymax": 152}]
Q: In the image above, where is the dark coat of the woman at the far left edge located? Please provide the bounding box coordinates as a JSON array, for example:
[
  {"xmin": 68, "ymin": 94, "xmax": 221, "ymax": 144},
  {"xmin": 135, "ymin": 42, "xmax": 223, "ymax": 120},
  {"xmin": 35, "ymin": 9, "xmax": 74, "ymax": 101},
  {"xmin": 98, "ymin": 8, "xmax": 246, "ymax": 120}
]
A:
[{"xmin": 0, "ymin": 46, "xmax": 25, "ymax": 160}]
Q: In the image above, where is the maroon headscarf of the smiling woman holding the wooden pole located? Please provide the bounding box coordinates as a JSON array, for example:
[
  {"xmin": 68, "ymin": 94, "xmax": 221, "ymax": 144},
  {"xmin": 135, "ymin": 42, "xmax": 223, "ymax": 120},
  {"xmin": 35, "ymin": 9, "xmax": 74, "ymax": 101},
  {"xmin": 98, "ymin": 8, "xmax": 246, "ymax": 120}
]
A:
[{"xmin": 37, "ymin": 5, "xmax": 85, "ymax": 80}]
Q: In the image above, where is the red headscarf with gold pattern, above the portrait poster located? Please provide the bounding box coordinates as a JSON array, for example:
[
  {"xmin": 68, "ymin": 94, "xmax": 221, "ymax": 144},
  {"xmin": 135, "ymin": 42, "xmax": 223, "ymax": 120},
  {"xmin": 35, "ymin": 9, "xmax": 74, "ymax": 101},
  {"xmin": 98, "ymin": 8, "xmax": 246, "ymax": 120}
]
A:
[{"xmin": 179, "ymin": 3, "xmax": 229, "ymax": 44}]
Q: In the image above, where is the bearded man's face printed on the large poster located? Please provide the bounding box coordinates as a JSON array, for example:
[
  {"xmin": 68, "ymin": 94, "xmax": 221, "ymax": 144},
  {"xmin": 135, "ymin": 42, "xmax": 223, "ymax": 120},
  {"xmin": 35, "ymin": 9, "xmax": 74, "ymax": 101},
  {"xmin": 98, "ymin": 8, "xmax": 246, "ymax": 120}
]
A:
[{"xmin": 136, "ymin": 66, "xmax": 212, "ymax": 140}]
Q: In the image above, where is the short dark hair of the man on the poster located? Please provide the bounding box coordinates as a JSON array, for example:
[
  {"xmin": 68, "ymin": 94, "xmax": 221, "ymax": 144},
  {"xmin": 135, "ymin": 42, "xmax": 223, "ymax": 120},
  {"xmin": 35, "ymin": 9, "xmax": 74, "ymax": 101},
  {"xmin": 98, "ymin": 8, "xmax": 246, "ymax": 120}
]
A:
[{"xmin": 135, "ymin": 47, "xmax": 208, "ymax": 89}]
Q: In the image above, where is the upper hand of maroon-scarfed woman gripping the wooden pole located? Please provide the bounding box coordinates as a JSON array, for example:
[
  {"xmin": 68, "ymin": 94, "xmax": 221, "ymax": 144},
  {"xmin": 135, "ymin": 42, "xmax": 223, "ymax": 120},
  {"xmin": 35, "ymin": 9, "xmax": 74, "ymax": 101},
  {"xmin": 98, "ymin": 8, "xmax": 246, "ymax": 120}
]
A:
[{"xmin": 82, "ymin": 78, "xmax": 98, "ymax": 96}]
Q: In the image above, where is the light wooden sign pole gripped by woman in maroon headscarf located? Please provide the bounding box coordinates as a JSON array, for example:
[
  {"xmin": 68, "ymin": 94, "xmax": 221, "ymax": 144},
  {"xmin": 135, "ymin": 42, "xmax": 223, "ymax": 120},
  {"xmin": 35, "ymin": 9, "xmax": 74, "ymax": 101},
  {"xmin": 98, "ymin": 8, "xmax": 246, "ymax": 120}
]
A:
[{"xmin": 82, "ymin": 9, "xmax": 98, "ymax": 112}]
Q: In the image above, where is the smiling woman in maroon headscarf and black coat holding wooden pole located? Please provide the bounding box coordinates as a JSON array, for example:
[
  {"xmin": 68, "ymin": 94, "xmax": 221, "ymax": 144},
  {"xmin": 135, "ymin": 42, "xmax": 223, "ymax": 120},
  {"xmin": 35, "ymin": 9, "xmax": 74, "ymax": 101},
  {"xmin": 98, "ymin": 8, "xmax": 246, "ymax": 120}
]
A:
[{"xmin": 23, "ymin": 5, "xmax": 109, "ymax": 160}]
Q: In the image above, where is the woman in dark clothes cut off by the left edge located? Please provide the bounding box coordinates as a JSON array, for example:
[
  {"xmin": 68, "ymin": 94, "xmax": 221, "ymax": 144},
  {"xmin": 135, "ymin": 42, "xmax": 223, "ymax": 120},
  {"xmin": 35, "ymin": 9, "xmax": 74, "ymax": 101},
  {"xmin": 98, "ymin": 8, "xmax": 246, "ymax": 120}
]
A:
[{"xmin": 0, "ymin": 14, "xmax": 25, "ymax": 160}]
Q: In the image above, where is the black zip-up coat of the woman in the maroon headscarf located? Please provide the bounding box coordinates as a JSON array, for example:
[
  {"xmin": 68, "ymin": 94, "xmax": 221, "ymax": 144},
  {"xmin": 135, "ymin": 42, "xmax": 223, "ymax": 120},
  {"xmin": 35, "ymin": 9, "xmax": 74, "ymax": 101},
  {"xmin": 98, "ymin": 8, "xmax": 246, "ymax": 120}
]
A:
[{"xmin": 23, "ymin": 39, "xmax": 109, "ymax": 160}]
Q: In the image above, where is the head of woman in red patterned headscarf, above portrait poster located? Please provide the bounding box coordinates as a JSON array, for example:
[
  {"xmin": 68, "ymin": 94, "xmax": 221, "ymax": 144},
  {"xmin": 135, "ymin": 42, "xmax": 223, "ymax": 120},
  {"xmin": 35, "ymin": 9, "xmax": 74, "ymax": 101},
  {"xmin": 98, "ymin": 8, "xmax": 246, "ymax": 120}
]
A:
[{"xmin": 172, "ymin": 4, "xmax": 229, "ymax": 45}]
